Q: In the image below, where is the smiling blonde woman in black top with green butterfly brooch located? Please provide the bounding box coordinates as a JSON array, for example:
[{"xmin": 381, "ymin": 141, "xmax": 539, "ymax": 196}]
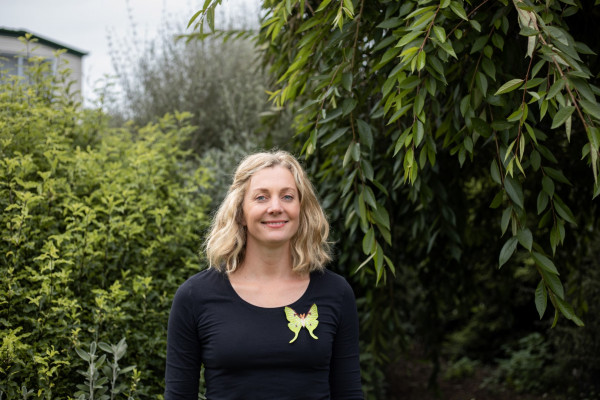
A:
[{"xmin": 165, "ymin": 151, "xmax": 363, "ymax": 400}]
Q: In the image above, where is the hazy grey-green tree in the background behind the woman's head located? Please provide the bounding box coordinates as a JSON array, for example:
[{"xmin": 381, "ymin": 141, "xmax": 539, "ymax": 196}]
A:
[{"xmin": 111, "ymin": 10, "xmax": 291, "ymax": 204}]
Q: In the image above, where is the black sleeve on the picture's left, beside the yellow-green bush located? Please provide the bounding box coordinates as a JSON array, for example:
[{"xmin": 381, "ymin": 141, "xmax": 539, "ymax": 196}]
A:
[{"xmin": 165, "ymin": 282, "xmax": 202, "ymax": 400}]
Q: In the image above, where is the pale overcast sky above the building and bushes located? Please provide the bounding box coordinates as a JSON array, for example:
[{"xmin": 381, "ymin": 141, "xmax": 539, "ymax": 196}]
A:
[{"xmin": 0, "ymin": 0, "xmax": 257, "ymax": 102}]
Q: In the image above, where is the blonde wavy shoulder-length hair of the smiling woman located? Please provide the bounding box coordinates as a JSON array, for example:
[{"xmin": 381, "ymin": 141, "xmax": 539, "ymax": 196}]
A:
[{"xmin": 205, "ymin": 151, "xmax": 331, "ymax": 273}]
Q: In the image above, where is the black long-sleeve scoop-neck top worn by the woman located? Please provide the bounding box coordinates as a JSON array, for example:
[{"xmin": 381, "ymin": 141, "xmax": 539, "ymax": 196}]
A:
[{"xmin": 165, "ymin": 269, "xmax": 363, "ymax": 400}]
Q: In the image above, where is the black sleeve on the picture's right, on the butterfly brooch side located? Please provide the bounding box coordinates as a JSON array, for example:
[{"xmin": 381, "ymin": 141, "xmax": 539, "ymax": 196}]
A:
[{"xmin": 329, "ymin": 282, "xmax": 363, "ymax": 400}]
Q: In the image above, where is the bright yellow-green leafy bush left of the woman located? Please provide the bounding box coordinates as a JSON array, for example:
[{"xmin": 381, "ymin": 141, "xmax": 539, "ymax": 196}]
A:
[{"xmin": 0, "ymin": 54, "xmax": 210, "ymax": 399}]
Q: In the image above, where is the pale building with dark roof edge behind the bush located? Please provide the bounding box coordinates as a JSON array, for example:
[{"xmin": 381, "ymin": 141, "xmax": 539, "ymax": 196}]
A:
[{"xmin": 0, "ymin": 27, "xmax": 87, "ymax": 94}]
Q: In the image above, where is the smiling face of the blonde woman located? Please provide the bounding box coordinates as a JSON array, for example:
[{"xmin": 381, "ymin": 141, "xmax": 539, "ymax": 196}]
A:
[{"xmin": 242, "ymin": 165, "xmax": 300, "ymax": 247}]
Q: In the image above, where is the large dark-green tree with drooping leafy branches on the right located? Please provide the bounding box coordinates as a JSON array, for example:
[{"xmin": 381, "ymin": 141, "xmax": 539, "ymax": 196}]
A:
[{"xmin": 190, "ymin": 0, "xmax": 600, "ymax": 396}]
